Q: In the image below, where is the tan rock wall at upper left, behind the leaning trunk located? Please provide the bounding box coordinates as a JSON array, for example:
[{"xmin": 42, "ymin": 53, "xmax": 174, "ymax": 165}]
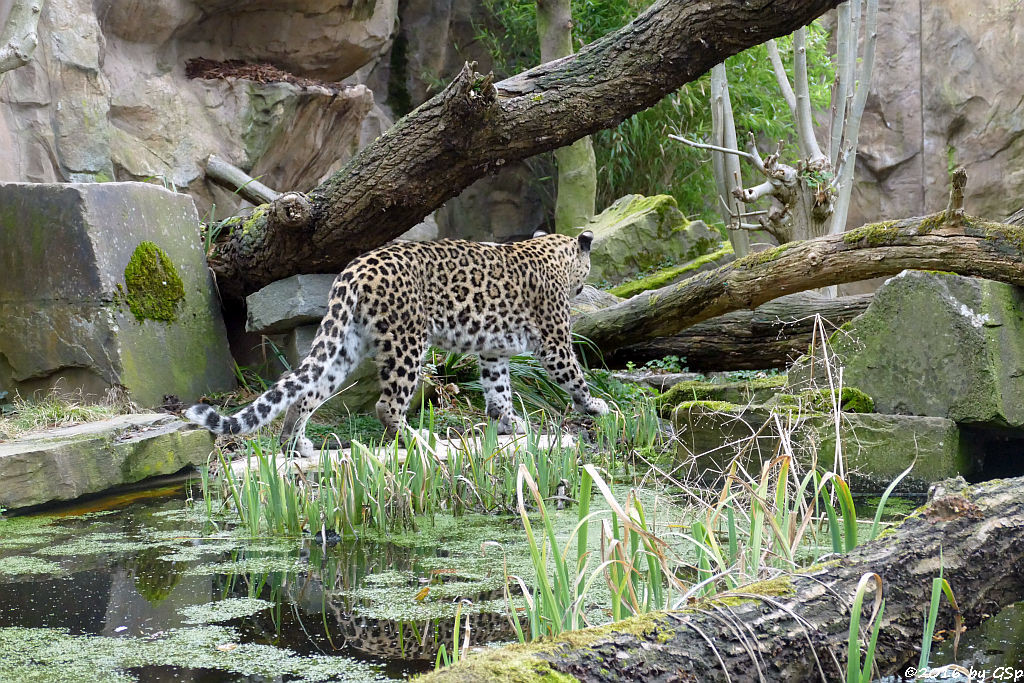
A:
[{"xmin": 0, "ymin": 0, "xmax": 397, "ymax": 216}]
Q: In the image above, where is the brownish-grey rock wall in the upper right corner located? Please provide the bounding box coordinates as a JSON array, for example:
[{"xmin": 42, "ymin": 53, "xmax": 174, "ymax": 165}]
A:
[{"xmin": 848, "ymin": 0, "xmax": 1024, "ymax": 226}]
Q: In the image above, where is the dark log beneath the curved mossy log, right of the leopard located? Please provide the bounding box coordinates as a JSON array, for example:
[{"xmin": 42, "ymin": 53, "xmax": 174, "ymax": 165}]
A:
[{"xmin": 601, "ymin": 294, "xmax": 873, "ymax": 373}]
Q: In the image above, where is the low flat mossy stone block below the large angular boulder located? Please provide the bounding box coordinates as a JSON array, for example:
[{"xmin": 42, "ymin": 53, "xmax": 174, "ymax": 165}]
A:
[{"xmin": 672, "ymin": 400, "xmax": 984, "ymax": 494}]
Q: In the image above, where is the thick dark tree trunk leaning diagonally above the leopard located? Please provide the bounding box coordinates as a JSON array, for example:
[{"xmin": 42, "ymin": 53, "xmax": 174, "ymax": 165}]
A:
[{"xmin": 210, "ymin": 0, "xmax": 838, "ymax": 300}]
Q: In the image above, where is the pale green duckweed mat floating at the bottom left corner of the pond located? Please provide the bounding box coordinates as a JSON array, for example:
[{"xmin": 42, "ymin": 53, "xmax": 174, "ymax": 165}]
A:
[{"xmin": 0, "ymin": 626, "xmax": 380, "ymax": 683}]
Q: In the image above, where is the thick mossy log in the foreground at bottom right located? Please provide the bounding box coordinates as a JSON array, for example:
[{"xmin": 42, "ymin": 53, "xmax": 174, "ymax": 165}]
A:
[{"xmin": 419, "ymin": 478, "xmax": 1024, "ymax": 683}]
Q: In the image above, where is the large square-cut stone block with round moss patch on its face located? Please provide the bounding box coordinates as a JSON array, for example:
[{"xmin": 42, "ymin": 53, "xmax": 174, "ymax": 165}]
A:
[{"xmin": 0, "ymin": 182, "xmax": 234, "ymax": 407}]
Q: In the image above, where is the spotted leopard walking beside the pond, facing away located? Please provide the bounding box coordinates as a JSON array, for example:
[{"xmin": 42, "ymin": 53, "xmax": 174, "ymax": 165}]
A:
[{"xmin": 185, "ymin": 230, "xmax": 608, "ymax": 457}]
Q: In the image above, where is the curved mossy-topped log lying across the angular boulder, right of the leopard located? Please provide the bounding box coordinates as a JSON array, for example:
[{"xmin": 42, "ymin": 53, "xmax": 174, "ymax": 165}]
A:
[{"xmin": 573, "ymin": 212, "xmax": 1024, "ymax": 348}]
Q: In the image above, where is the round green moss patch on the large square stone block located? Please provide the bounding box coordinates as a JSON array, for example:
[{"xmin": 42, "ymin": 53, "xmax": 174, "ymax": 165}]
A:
[{"xmin": 124, "ymin": 242, "xmax": 185, "ymax": 322}]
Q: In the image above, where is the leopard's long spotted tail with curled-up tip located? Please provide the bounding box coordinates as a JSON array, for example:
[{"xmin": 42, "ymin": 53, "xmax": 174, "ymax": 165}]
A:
[{"xmin": 185, "ymin": 273, "xmax": 359, "ymax": 434}]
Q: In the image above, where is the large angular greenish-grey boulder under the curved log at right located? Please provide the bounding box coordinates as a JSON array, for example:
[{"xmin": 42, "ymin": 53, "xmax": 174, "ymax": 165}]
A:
[{"xmin": 790, "ymin": 271, "xmax": 1024, "ymax": 427}]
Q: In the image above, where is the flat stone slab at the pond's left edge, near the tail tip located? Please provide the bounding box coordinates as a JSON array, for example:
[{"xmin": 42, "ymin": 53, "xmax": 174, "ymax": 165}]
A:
[{"xmin": 0, "ymin": 413, "xmax": 213, "ymax": 510}]
